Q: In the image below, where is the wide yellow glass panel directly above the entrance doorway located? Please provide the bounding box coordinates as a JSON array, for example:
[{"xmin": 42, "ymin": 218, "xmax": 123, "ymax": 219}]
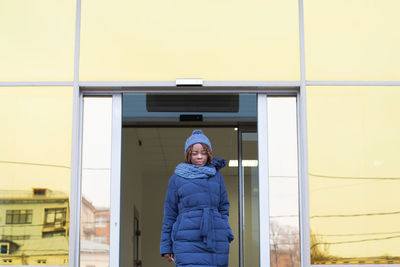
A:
[{"xmin": 79, "ymin": 0, "xmax": 300, "ymax": 81}]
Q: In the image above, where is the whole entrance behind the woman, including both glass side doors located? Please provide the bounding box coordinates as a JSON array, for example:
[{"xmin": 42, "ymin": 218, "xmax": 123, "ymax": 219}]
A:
[{"xmin": 80, "ymin": 90, "xmax": 299, "ymax": 267}]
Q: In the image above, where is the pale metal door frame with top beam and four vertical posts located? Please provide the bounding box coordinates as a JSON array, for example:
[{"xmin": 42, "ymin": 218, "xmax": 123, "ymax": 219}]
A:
[{"xmin": 70, "ymin": 84, "xmax": 310, "ymax": 267}]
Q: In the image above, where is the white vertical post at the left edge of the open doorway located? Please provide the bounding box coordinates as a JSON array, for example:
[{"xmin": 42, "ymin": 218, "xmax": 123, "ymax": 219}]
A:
[{"xmin": 110, "ymin": 94, "xmax": 122, "ymax": 267}]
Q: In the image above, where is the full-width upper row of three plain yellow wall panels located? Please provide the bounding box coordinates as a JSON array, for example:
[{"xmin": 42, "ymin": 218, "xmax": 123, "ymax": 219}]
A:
[{"xmin": 0, "ymin": 0, "xmax": 400, "ymax": 82}]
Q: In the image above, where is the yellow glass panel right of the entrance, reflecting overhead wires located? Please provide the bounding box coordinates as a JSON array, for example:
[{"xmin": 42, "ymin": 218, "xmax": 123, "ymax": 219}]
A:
[{"xmin": 307, "ymin": 86, "xmax": 400, "ymax": 264}]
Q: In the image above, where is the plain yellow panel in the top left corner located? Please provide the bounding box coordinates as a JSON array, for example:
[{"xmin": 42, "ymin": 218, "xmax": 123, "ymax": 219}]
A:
[{"xmin": 0, "ymin": 0, "xmax": 76, "ymax": 82}]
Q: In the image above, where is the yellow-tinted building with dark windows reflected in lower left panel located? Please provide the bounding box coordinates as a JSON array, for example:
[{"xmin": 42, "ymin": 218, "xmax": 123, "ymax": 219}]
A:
[{"xmin": 0, "ymin": 188, "xmax": 69, "ymax": 265}]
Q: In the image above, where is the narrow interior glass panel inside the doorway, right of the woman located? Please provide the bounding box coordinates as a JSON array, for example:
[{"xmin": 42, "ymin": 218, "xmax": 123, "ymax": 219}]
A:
[{"xmin": 242, "ymin": 132, "xmax": 260, "ymax": 266}]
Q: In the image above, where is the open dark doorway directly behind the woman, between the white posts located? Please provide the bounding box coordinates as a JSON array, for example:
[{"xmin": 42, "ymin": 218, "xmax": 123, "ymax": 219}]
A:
[{"xmin": 120, "ymin": 94, "xmax": 259, "ymax": 267}]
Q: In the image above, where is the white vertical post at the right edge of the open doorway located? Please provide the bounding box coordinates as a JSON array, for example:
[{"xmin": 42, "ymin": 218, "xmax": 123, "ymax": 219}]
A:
[{"xmin": 257, "ymin": 94, "xmax": 270, "ymax": 267}]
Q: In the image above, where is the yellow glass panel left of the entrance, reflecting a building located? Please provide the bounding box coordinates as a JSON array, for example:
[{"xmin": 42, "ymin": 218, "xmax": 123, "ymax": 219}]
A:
[{"xmin": 0, "ymin": 86, "xmax": 73, "ymax": 265}]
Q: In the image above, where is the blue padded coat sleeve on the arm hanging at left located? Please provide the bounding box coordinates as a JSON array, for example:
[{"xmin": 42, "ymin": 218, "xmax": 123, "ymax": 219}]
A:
[{"xmin": 160, "ymin": 176, "xmax": 178, "ymax": 255}]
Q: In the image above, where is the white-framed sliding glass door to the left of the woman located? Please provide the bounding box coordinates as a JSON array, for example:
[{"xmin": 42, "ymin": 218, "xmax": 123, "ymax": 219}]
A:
[{"xmin": 79, "ymin": 95, "xmax": 121, "ymax": 267}]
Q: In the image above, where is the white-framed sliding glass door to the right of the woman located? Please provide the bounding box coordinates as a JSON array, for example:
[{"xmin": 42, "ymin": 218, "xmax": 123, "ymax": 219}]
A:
[{"xmin": 258, "ymin": 95, "xmax": 300, "ymax": 267}]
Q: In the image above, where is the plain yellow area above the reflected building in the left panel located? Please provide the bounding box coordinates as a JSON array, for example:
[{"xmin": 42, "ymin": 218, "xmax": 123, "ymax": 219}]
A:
[{"xmin": 0, "ymin": 86, "xmax": 73, "ymax": 180}]
